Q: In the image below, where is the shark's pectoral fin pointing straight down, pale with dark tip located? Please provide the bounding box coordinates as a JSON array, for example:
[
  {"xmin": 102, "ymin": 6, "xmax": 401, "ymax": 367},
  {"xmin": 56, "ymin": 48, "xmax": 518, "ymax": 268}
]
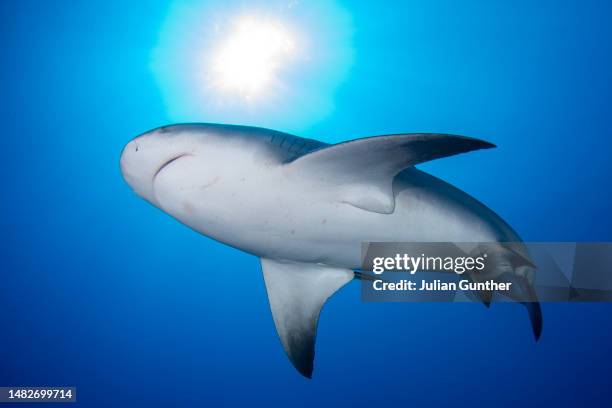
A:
[{"xmin": 261, "ymin": 258, "xmax": 354, "ymax": 378}]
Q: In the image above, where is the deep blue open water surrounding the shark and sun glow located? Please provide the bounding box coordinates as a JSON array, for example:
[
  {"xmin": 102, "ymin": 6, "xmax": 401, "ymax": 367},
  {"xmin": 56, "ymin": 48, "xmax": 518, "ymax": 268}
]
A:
[{"xmin": 0, "ymin": 0, "xmax": 612, "ymax": 407}]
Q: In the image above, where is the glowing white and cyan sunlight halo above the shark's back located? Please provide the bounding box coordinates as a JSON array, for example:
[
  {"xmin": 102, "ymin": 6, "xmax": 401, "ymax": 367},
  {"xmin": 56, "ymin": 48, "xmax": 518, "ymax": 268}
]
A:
[{"xmin": 151, "ymin": 0, "xmax": 354, "ymax": 131}]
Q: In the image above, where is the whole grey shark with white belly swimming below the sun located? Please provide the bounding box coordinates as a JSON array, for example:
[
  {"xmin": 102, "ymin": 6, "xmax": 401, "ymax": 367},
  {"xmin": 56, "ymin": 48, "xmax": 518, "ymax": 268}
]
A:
[{"xmin": 121, "ymin": 123, "xmax": 542, "ymax": 378}]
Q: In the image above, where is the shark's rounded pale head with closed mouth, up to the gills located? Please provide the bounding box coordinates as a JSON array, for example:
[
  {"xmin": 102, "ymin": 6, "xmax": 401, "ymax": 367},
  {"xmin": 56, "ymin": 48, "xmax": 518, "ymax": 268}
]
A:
[{"xmin": 120, "ymin": 123, "xmax": 278, "ymax": 241}]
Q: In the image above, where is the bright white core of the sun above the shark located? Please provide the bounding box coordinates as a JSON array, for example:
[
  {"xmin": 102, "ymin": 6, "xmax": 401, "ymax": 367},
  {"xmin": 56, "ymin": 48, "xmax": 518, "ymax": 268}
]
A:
[{"xmin": 210, "ymin": 18, "xmax": 295, "ymax": 98}]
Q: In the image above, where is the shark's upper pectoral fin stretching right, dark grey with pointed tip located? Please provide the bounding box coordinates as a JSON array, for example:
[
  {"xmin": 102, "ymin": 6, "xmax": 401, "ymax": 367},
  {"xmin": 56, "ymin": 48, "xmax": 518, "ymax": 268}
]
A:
[{"xmin": 288, "ymin": 133, "xmax": 495, "ymax": 214}]
